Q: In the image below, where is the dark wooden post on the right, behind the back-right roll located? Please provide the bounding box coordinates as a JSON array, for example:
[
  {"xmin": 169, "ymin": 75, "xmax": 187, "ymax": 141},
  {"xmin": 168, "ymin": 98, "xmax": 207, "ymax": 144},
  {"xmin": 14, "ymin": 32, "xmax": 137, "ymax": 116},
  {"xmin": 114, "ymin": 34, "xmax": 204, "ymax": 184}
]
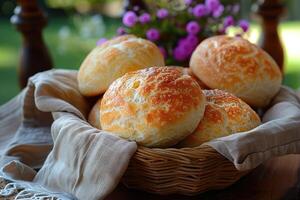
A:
[{"xmin": 254, "ymin": 0, "xmax": 285, "ymax": 72}]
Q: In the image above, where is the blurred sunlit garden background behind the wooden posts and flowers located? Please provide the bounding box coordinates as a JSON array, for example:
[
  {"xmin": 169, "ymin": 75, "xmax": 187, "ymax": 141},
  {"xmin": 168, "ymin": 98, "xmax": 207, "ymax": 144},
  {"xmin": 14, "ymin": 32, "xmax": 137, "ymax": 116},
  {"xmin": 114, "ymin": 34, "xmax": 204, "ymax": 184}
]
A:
[{"xmin": 0, "ymin": 0, "xmax": 300, "ymax": 105}]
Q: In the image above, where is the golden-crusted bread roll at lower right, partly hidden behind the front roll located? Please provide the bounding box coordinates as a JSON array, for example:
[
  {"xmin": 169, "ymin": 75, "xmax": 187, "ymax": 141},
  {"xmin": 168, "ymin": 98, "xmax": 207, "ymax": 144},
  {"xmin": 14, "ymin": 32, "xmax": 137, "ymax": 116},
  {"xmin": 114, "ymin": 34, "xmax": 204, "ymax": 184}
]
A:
[{"xmin": 179, "ymin": 89, "xmax": 261, "ymax": 147}]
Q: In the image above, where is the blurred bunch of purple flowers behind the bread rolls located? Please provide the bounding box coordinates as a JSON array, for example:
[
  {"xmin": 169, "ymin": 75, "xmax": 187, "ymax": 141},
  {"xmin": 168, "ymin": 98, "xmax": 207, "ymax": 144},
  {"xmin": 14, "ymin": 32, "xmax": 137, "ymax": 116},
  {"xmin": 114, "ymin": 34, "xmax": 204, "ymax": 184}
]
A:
[{"xmin": 104, "ymin": 0, "xmax": 249, "ymax": 65}]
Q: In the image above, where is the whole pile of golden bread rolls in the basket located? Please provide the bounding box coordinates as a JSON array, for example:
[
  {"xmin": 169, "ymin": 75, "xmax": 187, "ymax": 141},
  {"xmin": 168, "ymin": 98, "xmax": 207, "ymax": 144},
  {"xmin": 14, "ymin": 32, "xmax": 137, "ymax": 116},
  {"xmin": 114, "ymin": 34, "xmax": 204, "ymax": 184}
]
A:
[{"xmin": 78, "ymin": 35, "xmax": 282, "ymax": 148}]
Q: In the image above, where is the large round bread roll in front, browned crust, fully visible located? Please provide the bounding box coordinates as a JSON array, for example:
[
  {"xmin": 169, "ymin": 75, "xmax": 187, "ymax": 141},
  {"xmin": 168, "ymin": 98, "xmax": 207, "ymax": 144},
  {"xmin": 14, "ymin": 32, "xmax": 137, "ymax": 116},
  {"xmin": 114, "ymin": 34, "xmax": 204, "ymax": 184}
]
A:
[{"xmin": 100, "ymin": 67, "xmax": 206, "ymax": 147}]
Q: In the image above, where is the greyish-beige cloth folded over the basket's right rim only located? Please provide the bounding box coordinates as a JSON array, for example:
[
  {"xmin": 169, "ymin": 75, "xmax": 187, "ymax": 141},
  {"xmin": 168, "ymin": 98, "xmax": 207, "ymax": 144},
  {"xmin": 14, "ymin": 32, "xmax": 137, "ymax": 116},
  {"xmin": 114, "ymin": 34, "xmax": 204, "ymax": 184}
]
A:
[{"xmin": 205, "ymin": 86, "xmax": 300, "ymax": 171}]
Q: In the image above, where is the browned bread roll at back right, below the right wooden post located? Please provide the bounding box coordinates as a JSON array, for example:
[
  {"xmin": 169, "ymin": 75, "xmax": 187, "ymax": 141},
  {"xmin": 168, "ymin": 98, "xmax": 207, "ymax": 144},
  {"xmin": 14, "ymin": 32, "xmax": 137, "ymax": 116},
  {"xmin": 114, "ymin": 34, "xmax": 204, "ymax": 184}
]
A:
[{"xmin": 190, "ymin": 36, "xmax": 282, "ymax": 107}]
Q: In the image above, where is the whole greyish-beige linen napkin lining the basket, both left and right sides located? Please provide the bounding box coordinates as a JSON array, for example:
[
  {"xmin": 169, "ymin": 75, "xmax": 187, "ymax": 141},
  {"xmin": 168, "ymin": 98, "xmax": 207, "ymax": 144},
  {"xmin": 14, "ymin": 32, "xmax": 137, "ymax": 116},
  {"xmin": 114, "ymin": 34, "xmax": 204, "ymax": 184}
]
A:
[{"xmin": 0, "ymin": 70, "xmax": 300, "ymax": 200}]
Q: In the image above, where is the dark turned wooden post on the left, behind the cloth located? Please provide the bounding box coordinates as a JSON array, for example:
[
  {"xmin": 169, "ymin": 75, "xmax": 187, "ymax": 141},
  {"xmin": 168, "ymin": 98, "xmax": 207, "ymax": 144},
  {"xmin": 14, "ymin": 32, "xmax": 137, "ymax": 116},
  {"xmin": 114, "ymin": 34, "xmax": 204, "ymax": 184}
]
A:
[{"xmin": 11, "ymin": 0, "xmax": 52, "ymax": 88}]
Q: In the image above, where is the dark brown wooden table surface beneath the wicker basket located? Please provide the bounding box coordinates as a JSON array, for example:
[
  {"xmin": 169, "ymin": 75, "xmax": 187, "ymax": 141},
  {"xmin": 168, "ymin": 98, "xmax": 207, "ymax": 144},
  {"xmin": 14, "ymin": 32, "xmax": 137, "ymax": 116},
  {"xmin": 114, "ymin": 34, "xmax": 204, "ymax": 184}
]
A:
[{"xmin": 106, "ymin": 155, "xmax": 300, "ymax": 200}]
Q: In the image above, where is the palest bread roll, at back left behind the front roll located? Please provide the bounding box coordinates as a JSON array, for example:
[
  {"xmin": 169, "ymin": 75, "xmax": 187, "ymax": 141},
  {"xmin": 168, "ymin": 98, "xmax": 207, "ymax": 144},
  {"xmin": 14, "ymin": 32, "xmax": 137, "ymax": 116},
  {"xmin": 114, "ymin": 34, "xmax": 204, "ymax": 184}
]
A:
[{"xmin": 78, "ymin": 35, "xmax": 164, "ymax": 96}]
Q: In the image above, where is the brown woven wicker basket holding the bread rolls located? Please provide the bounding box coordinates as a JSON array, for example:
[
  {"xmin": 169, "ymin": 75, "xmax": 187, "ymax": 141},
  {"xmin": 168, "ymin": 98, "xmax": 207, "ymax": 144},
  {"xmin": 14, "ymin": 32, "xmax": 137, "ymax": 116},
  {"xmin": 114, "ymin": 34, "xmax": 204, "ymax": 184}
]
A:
[{"xmin": 123, "ymin": 145, "xmax": 247, "ymax": 195}]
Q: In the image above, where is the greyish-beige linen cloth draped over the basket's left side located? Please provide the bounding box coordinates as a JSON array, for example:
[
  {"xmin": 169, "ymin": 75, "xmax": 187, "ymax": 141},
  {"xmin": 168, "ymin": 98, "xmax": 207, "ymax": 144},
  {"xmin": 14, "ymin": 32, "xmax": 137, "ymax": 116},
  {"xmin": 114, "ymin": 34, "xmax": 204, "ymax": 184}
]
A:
[{"xmin": 0, "ymin": 70, "xmax": 137, "ymax": 200}]
